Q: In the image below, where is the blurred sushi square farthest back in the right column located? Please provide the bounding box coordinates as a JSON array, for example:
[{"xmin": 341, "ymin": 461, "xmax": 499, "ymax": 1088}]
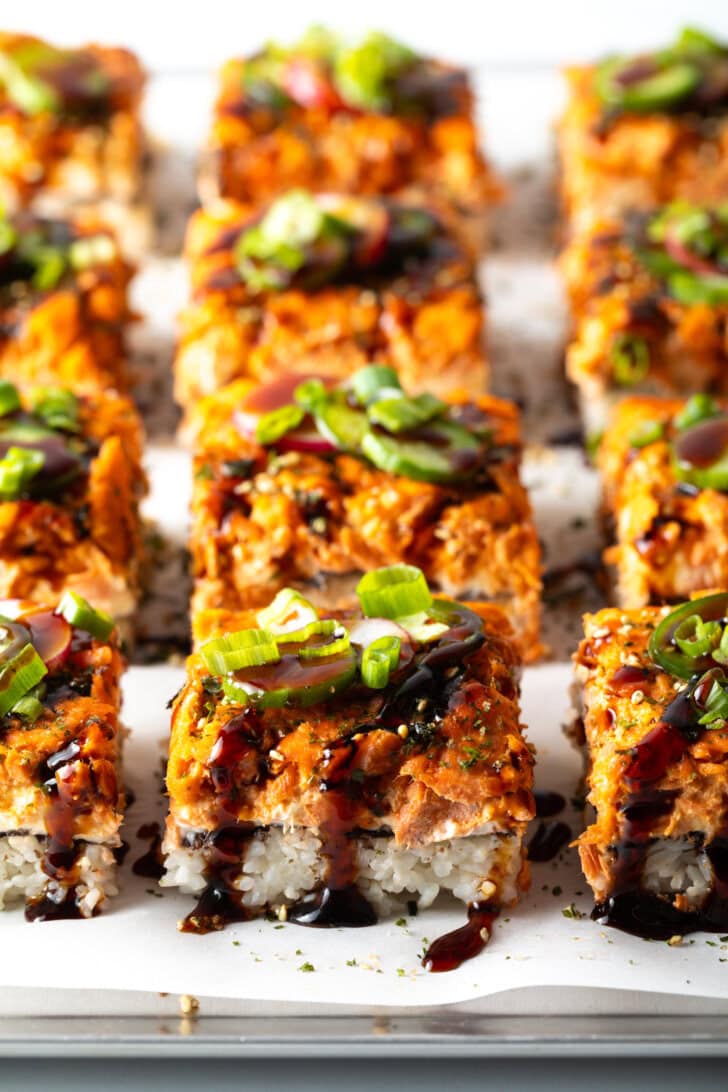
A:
[{"xmin": 559, "ymin": 27, "xmax": 728, "ymax": 230}]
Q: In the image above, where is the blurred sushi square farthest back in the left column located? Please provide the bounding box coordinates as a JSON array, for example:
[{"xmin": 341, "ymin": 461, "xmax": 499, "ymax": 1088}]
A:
[{"xmin": 0, "ymin": 33, "xmax": 148, "ymax": 249}]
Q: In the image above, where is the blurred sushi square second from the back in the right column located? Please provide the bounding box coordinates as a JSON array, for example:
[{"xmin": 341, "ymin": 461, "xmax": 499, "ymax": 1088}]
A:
[{"xmin": 561, "ymin": 202, "xmax": 728, "ymax": 431}]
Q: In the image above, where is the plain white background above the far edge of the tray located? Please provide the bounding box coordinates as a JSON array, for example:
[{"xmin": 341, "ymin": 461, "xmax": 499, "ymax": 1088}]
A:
[{"xmin": 0, "ymin": 0, "xmax": 728, "ymax": 70}]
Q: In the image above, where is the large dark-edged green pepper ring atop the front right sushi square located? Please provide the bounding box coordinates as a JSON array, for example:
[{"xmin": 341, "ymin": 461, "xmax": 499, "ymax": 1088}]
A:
[{"xmin": 649, "ymin": 592, "xmax": 728, "ymax": 679}]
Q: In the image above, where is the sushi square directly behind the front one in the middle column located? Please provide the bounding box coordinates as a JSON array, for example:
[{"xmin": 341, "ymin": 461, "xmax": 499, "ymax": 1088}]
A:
[{"xmin": 191, "ymin": 365, "xmax": 540, "ymax": 660}]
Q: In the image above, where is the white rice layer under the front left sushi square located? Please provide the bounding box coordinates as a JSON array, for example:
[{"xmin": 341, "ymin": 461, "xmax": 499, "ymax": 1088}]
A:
[{"xmin": 0, "ymin": 834, "xmax": 118, "ymax": 917}]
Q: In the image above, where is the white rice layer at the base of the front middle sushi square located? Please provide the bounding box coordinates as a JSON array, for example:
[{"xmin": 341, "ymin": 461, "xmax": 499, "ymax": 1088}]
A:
[{"xmin": 160, "ymin": 827, "xmax": 522, "ymax": 914}]
